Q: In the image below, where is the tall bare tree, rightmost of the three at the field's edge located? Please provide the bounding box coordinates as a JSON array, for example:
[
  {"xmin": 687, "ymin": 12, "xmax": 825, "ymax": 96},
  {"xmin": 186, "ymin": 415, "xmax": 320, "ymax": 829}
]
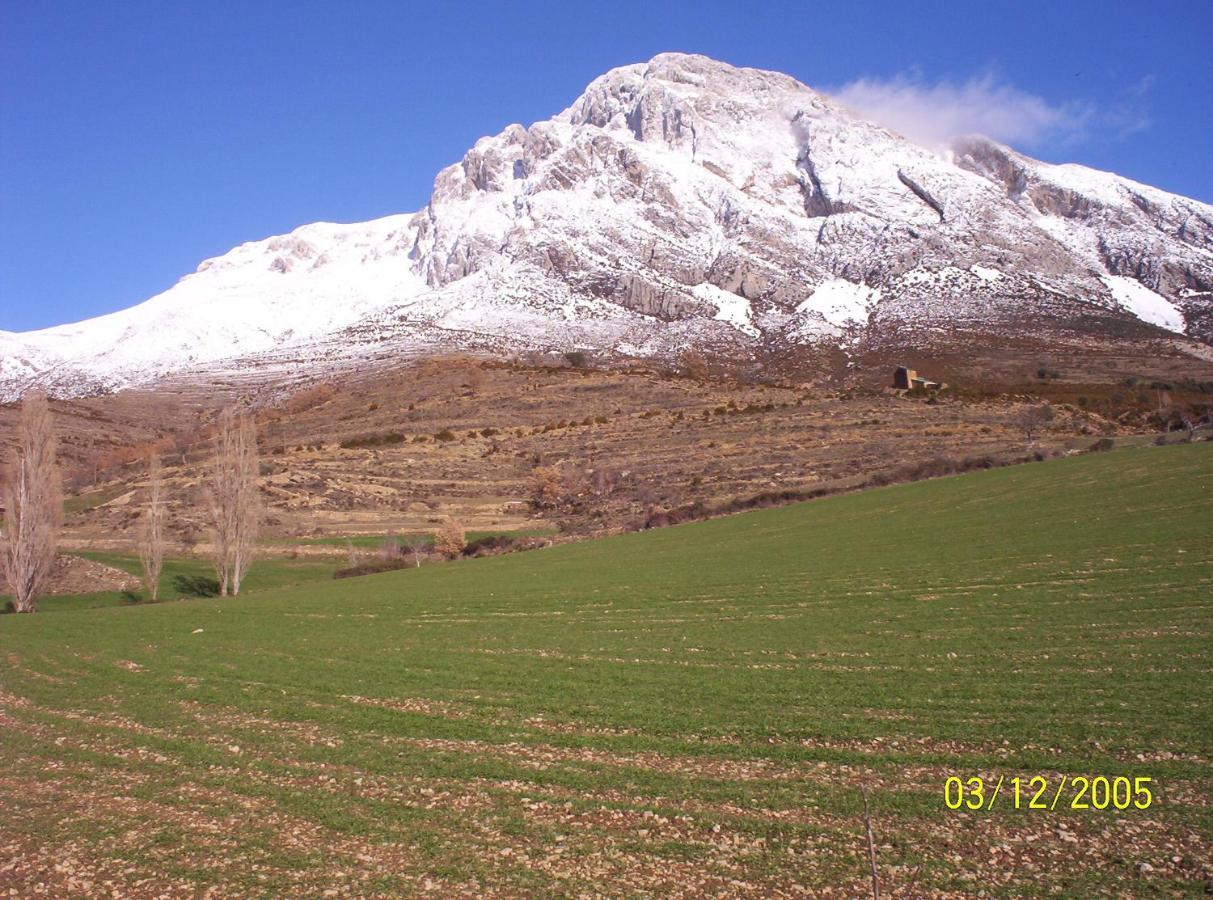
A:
[{"xmin": 210, "ymin": 408, "xmax": 261, "ymax": 597}]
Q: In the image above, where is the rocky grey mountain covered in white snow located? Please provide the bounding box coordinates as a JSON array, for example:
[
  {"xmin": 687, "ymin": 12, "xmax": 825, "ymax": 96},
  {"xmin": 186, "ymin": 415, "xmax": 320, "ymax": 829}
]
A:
[{"xmin": 0, "ymin": 53, "xmax": 1213, "ymax": 398}]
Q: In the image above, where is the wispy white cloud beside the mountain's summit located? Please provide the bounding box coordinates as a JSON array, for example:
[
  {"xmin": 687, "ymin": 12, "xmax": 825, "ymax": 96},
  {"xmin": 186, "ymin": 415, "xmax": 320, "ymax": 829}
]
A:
[{"xmin": 831, "ymin": 73, "xmax": 1095, "ymax": 147}]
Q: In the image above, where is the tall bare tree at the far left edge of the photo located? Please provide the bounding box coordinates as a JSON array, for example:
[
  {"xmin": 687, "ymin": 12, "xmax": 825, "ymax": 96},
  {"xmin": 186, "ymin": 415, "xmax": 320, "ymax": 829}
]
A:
[{"xmin": 0, "ymin": 392, "xmax": 63, "ymax": 613}]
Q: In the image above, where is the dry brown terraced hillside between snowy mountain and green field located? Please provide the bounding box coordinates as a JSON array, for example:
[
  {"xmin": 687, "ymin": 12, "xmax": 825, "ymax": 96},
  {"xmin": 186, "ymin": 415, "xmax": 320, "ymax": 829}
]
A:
[{"xmin": 0, "ymin": 358, "xmax": 1200, "ymax": 554}]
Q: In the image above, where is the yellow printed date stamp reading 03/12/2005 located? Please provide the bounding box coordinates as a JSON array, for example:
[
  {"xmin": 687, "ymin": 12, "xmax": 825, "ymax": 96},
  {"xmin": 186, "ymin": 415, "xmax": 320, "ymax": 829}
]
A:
[{"xmin": 944, "ymin": 775, "xmax": 1154, "ymax": 811}]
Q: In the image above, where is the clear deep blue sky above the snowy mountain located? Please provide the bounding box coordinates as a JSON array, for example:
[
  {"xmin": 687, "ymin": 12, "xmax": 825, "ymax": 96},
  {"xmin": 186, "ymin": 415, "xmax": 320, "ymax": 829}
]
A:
[{"xmin": 0, "ymin": 0, "xmax": 1213, "ymax": 331}]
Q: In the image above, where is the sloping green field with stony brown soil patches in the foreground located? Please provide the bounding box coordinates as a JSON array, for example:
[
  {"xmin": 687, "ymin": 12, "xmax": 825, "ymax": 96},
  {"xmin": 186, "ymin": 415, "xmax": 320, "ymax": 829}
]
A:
[{"xmin": 0, "ymin": 444, "xmax": 1213, "ymax": 896}]
